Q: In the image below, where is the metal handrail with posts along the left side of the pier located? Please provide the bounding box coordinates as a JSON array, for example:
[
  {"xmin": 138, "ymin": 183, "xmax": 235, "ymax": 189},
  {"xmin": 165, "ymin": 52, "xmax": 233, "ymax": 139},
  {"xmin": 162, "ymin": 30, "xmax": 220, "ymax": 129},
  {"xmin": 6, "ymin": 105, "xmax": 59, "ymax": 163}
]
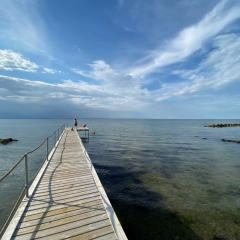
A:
[{"xmin": 0, "ymin": 124, "xmax": 66, "ymax": 238}]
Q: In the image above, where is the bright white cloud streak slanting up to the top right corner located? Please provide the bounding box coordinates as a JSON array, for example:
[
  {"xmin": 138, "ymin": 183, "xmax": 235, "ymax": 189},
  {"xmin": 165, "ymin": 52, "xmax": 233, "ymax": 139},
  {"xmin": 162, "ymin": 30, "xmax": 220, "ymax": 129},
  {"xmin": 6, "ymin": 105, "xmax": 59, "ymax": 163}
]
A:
[{"xmin": 129, "ymin": 0, "xmax": 240, "ymax": 77}]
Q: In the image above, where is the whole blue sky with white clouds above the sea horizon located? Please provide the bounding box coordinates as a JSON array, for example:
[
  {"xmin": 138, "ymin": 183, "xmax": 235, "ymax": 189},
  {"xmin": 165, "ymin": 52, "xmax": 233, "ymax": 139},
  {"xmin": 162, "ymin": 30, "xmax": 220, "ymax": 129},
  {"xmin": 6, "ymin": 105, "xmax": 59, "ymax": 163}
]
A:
[{"xmin": 0, "ymin": 0, "xmax": 240, "ymax": 119}]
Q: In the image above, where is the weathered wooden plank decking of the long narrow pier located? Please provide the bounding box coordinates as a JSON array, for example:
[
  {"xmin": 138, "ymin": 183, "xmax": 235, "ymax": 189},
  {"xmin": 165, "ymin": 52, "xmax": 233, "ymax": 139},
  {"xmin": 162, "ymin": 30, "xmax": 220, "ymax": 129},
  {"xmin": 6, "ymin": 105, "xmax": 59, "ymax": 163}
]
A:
[{"xmin": 3, "ymin": 129, "xmax": 127, "ymax": 240}]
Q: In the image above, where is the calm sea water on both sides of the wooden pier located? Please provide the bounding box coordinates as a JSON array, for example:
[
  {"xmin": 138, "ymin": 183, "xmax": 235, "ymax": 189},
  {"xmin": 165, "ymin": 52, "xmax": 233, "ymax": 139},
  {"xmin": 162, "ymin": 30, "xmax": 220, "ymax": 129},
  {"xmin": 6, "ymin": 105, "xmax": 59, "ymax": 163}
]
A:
[{"xmin": 0, "ymin": 119, "xmax": 240, "ymax": 240}]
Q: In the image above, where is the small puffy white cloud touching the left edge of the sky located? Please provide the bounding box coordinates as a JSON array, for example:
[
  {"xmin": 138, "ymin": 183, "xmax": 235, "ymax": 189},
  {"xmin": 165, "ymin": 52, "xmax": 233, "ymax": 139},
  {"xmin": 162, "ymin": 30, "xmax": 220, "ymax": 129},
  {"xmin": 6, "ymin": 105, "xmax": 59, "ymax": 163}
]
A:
[{"xmin": 0, "ymin": 49, "xmax": 38, "ymax": 72}]
